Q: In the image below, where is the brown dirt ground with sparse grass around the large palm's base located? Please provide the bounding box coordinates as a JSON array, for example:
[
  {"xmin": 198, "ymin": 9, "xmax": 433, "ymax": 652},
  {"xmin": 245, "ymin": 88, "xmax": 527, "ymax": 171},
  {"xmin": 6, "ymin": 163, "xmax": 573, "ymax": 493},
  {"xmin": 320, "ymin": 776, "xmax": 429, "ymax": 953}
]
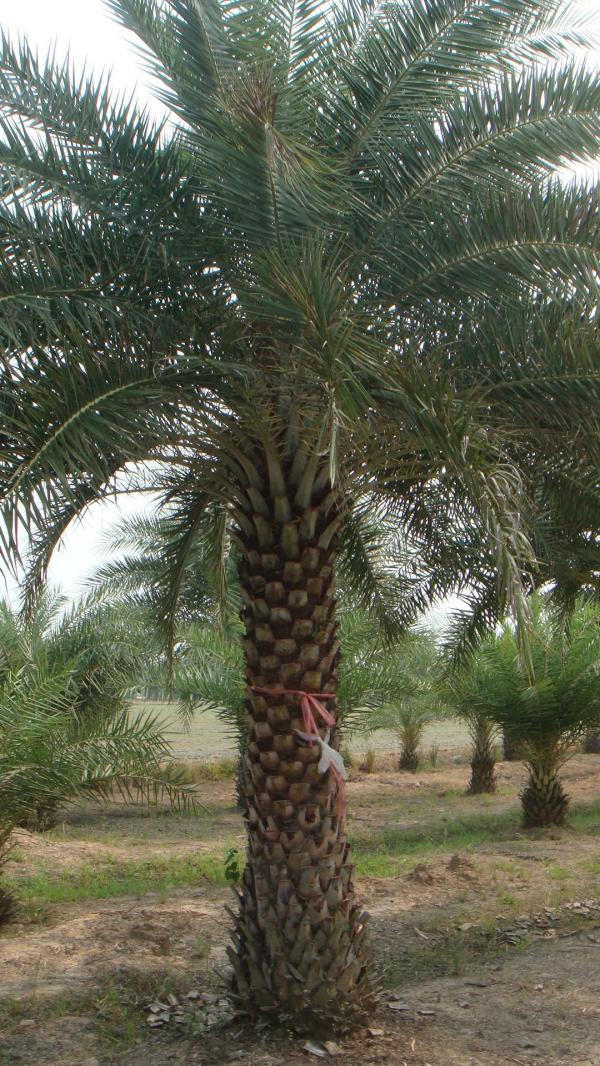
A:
[{"xmin": 0, "ymin": 753, "xmax": 600, "ymax": 1066}]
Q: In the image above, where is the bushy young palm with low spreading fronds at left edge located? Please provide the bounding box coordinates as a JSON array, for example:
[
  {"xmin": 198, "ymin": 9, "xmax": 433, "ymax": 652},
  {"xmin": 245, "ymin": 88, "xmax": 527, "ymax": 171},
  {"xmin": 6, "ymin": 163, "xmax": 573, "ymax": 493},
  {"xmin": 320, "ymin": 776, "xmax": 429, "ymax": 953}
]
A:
[{"xmin": 0, "ymin": 596, "xmax": 191, "ymax": 827}]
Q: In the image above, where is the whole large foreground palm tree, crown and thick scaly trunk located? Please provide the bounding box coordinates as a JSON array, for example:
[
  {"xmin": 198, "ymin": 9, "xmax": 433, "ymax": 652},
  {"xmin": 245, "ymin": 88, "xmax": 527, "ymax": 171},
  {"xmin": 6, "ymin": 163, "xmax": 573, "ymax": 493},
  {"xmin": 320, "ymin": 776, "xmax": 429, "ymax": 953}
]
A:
[{"xmin": 0, "ymin": 0, "xmax": 600, "ymax": 1023}]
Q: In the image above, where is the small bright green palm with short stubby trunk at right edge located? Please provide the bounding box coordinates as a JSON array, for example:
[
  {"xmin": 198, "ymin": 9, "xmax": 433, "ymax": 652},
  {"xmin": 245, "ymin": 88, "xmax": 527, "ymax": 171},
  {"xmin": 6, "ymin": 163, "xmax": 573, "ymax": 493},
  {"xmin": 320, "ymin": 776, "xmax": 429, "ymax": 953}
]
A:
[{"xmin": 455, "ymin": 598, "xmax": 600, "ymax": 828}]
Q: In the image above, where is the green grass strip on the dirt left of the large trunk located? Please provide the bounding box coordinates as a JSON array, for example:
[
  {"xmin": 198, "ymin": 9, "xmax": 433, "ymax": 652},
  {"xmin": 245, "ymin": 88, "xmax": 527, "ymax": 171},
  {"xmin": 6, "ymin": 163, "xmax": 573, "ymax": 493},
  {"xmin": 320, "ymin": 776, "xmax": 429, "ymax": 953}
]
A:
[{"xmin": 6, "ymin": 852, "xmax": 234, "ymax": 906}]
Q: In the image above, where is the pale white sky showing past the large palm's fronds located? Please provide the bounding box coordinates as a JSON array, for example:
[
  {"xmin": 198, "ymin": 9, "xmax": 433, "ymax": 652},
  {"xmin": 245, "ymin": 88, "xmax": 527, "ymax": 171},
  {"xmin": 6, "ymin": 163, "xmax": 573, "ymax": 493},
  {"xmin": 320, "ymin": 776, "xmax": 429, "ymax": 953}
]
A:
[{"xmin": 0, "ymin": 0, "xmax": 600, "ymax": 598}]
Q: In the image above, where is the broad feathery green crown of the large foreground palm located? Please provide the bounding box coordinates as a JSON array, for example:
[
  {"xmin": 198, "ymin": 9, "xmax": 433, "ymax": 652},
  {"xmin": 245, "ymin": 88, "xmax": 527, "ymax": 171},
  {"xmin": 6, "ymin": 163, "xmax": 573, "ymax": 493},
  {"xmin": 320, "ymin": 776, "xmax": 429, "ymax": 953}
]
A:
[{"xmin": 0, "ymin": 0, "xmax": 600, "ymax": 631}]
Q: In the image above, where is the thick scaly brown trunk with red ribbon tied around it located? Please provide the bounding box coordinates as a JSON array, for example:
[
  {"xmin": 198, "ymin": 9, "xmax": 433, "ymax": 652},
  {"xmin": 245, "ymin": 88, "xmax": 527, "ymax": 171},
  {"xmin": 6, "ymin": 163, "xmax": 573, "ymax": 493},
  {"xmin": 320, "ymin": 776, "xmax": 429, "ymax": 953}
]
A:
[{"xmin": 230, "ymin": 456, "xmax": 370, "ymax": 1032}]
